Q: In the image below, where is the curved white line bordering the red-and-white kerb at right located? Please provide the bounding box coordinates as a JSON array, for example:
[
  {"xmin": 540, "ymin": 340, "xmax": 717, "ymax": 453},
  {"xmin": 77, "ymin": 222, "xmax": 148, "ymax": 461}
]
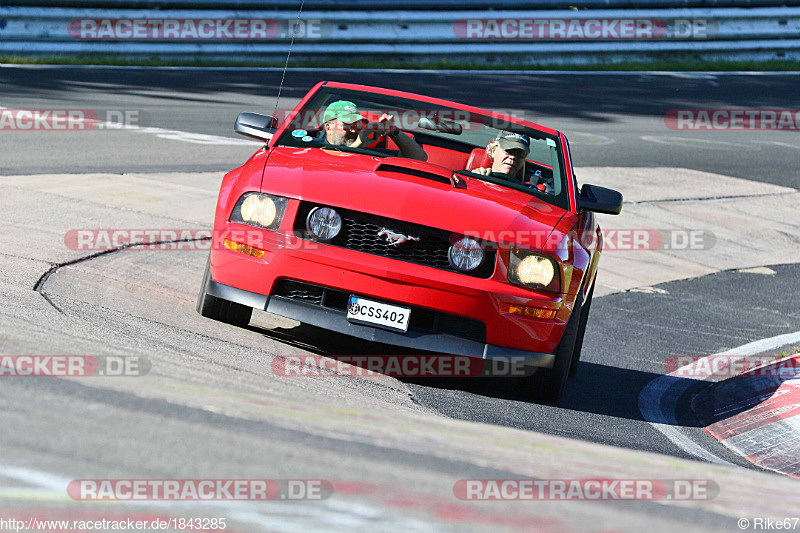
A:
[{"xmin": 639, "ymin": 331, "xmax": 800, "ymax": 466}]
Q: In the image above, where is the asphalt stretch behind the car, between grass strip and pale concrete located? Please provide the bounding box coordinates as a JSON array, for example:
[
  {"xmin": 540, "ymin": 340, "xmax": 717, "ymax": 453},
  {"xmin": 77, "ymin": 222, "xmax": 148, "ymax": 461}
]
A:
[{"xmin": 0, "ymin": 68, "xmax": 800, "ymax": 188}]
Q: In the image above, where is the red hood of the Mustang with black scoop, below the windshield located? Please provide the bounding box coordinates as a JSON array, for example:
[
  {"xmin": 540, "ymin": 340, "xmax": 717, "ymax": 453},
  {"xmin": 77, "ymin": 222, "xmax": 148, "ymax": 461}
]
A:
[{"xmin": 261, "ymin": 147, "xmax": 565, "ymax": 248}]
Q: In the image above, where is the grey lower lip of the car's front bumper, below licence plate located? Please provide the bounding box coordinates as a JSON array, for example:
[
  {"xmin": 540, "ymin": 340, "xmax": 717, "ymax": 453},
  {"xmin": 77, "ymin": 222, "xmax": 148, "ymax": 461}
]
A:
[{"xmin": 208, "ymin": 281, "xmax": 554, "ymax": 368}]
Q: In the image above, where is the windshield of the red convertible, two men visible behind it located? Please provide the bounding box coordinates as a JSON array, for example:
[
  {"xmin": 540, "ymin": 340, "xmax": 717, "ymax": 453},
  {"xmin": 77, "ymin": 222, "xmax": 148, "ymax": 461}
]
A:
[{"xmin": 275, "ymin": 86, "xmax": 568, "ymax": 208}]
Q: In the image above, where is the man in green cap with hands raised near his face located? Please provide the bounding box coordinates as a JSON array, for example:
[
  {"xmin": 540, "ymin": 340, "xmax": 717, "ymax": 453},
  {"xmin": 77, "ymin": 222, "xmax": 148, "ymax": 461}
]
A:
[{"xmin": 322, "ymin": 100, "xmax": 428, "ymax": 161}]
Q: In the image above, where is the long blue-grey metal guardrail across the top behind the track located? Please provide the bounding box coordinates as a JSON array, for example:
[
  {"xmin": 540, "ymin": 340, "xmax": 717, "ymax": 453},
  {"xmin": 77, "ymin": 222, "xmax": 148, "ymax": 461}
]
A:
[{"xmin": 0, "ymin": 7, "xmax": 800, "ymax": 64}]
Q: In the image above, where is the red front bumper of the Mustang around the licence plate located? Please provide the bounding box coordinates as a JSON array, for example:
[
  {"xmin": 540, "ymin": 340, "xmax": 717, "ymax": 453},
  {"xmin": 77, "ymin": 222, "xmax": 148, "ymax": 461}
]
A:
[{"xmin": 211, "ymin": 216, "xmax": 574, "ymax": 357}]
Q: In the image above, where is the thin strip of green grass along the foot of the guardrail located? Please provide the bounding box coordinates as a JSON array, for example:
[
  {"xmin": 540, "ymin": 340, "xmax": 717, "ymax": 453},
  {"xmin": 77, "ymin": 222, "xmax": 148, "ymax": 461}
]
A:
[{"xmin": 0, "ymin": 56, "xmax": 800, "ymax": 72}]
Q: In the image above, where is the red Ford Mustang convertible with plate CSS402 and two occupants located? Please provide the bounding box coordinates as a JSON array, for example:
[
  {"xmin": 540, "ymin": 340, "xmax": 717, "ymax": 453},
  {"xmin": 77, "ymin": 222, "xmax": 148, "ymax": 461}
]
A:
[{"xmin": 197, "ymin": 82, "xmax": 622, "ymax": 401}]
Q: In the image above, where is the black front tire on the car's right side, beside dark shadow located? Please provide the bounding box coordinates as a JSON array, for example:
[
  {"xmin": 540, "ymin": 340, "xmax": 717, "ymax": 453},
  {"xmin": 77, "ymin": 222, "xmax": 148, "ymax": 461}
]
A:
[{"xmin": 519, "ymin": 294, "xmax": 582, "ymax": 403}]
